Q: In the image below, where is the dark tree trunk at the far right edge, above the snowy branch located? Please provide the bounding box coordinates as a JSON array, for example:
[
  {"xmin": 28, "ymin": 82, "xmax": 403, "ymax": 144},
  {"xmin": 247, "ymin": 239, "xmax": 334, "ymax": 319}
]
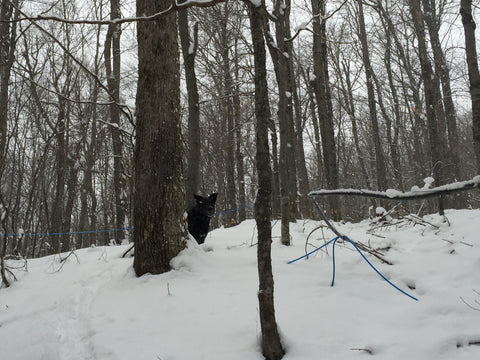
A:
[{"xmin": 460, "ymin": 0, "xmax": 480, "ymax": 172}]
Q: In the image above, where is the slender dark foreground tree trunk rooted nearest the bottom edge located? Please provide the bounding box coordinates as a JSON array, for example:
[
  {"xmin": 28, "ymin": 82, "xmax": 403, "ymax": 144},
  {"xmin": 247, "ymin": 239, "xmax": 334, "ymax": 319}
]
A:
[{"xmin": 249, "ymin": 1, "xmax": 285, "ymax": 360}]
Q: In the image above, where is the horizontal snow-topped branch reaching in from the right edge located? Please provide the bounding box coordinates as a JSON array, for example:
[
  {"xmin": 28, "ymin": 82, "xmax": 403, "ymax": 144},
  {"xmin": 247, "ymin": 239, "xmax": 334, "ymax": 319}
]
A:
[{"xmin": 308, "ymin": 175, "xmax": 480, "ymax": 200}]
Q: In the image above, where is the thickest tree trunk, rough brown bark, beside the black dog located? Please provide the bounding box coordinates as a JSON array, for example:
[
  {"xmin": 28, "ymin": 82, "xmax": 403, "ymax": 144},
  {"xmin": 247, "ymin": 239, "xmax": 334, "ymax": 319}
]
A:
[{"xmin": 133, "ymin": 0, "xmax": 187, "ymax": 276}]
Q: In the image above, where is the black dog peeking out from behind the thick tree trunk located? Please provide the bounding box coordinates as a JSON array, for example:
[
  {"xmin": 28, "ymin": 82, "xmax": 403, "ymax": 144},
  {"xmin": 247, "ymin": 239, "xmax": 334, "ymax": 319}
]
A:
[{"xmin": 187, "ymin": 193, "xmax": 217, "ymax": 244}]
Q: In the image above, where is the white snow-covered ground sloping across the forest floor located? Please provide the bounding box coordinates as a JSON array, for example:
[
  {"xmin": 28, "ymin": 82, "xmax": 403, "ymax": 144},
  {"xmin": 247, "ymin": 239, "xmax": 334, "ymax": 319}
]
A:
[{"xmin": 0, "ymin": 210, "xmax": 480, "ymax": 360}]
